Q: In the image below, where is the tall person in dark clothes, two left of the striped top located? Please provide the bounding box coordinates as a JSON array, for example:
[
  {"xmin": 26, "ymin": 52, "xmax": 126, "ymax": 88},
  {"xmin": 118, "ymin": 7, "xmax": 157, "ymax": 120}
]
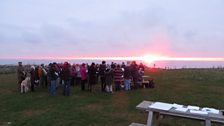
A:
[{"xmin": 99, "ymin": 61, "xmax": 107, "ymax": 92}]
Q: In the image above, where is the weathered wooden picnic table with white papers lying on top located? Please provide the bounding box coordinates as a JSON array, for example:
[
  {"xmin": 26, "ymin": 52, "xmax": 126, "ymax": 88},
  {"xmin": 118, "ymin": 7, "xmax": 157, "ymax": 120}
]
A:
[{"xmin": 131, "ymin": 101, "xmax": 224, "ymax": 126}]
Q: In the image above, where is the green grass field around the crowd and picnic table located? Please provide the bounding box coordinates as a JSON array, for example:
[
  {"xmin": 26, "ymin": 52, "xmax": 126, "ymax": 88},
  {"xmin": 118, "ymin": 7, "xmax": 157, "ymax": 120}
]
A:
[{"xmin": 0, "ymin": 69, "xmax": 224, "ymax": 126}]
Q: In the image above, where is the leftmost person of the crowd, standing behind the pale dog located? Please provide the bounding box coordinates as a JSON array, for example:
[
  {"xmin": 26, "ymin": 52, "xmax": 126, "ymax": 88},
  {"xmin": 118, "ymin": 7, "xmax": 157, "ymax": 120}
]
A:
[{"xmin": 17, "ymin": 62, "xmax": 26, "ymax": 91}]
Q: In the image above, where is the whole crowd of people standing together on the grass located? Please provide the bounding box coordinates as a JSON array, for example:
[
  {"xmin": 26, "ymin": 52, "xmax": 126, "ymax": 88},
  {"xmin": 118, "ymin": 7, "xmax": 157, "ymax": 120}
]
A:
[{"xmin": 17, "ymin": 61, "xmax": 153, "ymax": 96}]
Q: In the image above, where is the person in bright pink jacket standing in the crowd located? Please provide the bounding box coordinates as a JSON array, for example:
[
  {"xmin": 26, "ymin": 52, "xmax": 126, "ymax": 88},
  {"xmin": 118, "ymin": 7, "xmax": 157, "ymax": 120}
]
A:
[{"xmin": 80, "ymin": 63, "xmax": 87, "ymax": 91}]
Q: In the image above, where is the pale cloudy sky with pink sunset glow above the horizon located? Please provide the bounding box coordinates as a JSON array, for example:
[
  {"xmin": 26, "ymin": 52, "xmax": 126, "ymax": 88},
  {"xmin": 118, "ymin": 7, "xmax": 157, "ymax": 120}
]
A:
[{"xmin": 0, "ymin": 0, "xmax": 224, "ymax": 59}]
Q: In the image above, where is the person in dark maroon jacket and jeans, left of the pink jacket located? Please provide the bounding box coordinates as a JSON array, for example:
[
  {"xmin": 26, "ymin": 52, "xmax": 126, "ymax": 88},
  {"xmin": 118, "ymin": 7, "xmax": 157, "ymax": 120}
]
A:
[{"xmin": 61, "ymin": 62, "xmax": 71, "ymax": 96}]
